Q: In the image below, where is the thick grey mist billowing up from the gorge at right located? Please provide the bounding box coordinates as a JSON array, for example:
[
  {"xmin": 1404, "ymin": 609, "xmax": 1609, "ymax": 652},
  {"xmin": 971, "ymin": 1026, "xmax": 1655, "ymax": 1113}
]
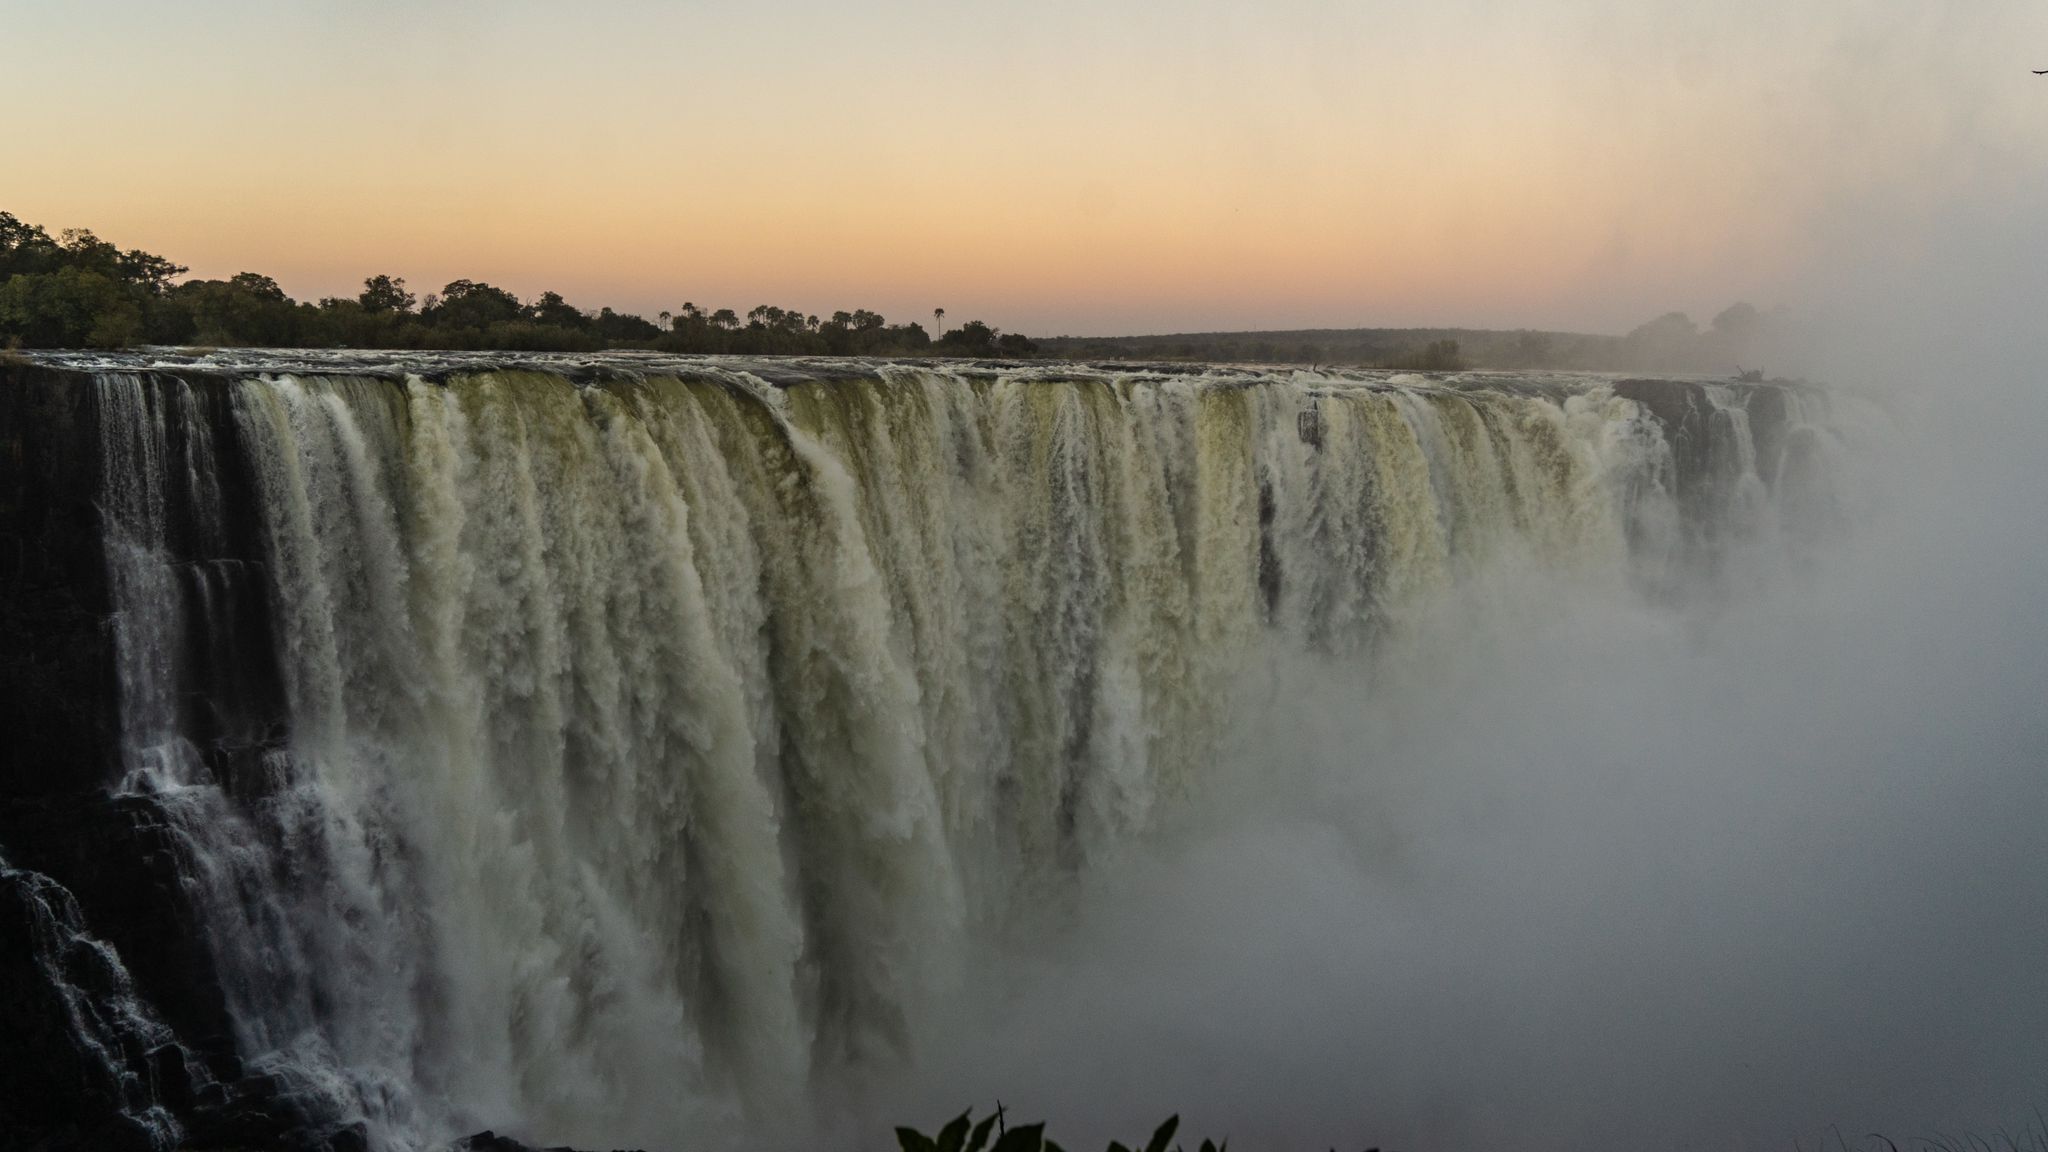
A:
[{"xmin": 872, "ymin": 201, "xmax": 2048, "ymax": 1148}]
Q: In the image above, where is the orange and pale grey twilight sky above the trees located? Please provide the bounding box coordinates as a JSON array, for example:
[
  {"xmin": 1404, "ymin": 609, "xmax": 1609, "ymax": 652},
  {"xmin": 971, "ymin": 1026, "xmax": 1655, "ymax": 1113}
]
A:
[{"xmin": 0, "ymin": 0, "xmax": 2048, "ymax": 334}]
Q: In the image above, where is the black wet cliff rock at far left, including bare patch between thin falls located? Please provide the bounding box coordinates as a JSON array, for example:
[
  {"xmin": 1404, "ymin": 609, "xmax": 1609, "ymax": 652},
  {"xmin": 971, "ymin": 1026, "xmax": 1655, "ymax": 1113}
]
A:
[{"xmin": 0, "ymin": 363, "xmax": 323, "ymax": 1152}]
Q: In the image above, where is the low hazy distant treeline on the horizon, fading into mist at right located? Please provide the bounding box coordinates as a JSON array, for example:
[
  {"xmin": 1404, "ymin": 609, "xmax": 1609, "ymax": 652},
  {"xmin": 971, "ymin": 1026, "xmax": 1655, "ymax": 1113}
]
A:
[{"xmin": 1038, "ymin": 303, "xmax": 1804, "ymax": 375}]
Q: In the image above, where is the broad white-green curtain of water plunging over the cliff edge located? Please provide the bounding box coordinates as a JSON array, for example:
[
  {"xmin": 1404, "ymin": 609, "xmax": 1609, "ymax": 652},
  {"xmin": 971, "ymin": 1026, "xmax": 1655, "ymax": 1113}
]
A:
[{"xmin": 72, "ymin": 357, "xmax": 1839, "ymax": 1148}]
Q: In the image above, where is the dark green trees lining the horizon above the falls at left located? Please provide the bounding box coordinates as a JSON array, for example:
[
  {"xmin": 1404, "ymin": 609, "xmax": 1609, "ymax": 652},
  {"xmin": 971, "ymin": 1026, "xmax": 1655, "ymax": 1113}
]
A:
[{"xmin": 0, "ymin": 213, "xmax": 1038, "ymax": 357}]
